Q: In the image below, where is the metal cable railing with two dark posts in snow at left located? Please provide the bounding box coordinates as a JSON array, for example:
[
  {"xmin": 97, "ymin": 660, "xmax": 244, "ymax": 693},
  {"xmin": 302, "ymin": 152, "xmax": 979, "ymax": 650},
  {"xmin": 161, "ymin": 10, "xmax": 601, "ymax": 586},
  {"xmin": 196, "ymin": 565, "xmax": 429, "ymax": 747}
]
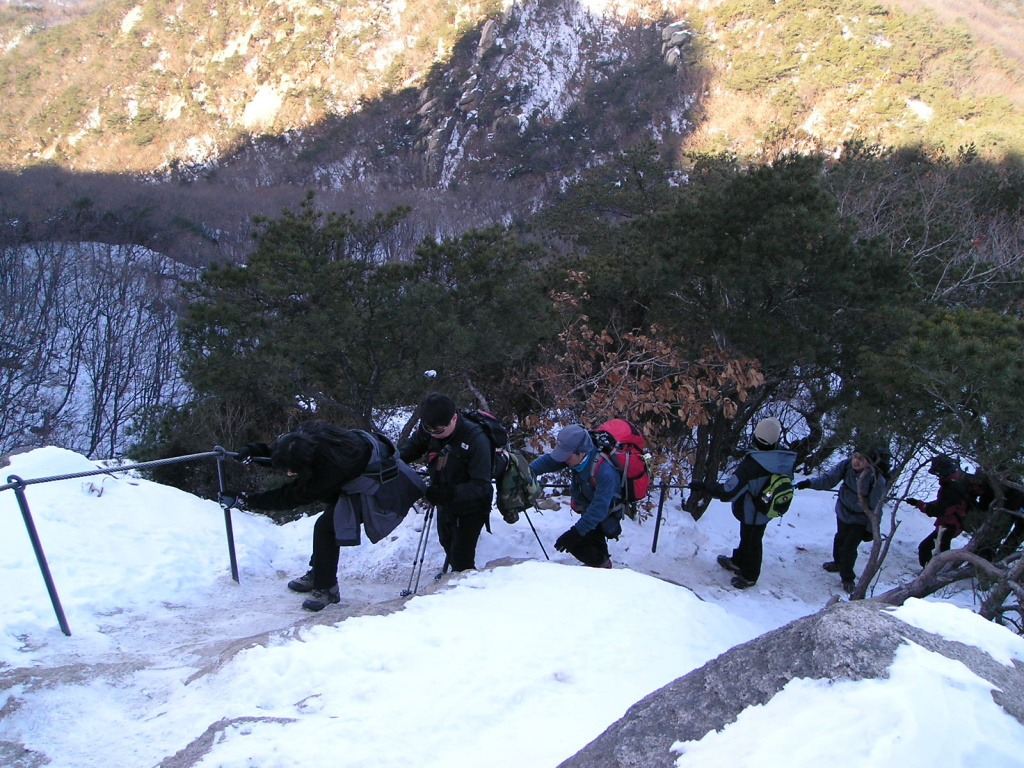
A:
[{"xmin": 0, "ymin": 445, "xmax": 239, "ymax": 637}]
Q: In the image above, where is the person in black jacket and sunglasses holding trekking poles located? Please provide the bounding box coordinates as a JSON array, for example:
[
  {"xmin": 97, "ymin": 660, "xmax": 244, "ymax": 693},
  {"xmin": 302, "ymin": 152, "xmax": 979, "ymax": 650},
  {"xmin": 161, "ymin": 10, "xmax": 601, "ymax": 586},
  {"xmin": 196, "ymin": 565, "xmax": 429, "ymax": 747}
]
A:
[{"xmin": 399, "ymin": 392, "xmax": 494, "ymax": 570}]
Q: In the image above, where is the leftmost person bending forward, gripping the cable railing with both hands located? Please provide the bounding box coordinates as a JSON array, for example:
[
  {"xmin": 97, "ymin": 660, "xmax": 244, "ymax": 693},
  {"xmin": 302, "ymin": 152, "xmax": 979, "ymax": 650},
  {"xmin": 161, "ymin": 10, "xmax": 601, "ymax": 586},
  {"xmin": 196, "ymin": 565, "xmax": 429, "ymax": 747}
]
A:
[{"xmin": 221, "ymin": 421, "xmax": 373, "ymax": 610}]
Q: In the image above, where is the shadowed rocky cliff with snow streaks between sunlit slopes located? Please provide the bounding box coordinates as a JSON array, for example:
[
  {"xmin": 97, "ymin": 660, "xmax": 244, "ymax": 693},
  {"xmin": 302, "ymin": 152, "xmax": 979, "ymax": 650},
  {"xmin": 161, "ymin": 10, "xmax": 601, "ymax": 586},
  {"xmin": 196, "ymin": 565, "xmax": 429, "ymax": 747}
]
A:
[{"xmin": 178, "ymin": 0, "xmax": 694, "ymax": 196}]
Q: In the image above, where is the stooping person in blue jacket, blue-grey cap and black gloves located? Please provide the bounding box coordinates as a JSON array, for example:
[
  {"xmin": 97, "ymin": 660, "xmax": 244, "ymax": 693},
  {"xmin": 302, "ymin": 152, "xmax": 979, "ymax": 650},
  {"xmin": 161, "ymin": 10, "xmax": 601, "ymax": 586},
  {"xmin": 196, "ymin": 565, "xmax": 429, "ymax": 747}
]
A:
[{"xmin": 529, "ymin": 424, "xmax": 623, "ymax": 568}]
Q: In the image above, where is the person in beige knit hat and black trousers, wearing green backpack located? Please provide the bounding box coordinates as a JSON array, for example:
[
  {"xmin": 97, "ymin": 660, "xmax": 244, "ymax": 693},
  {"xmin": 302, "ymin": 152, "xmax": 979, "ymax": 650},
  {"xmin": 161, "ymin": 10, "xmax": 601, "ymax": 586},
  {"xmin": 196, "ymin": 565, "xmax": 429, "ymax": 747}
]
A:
[{"xmin": 690, "ymin": 418, "xmax": 797, "ymax": 589}]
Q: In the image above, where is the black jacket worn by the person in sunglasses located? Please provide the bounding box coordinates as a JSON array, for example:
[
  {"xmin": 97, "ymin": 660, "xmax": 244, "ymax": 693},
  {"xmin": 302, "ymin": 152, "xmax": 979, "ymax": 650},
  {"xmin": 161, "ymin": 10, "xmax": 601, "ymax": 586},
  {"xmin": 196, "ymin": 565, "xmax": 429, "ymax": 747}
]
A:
[{"xmin": 398, "ymin": 414, "xmax": 494, "ymax": 515}]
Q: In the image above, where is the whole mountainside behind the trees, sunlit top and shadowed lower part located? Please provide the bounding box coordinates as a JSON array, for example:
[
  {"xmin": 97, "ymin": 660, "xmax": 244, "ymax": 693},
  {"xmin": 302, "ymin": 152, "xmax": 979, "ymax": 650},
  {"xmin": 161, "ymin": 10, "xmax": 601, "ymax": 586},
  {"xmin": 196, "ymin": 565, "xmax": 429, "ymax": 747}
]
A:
[{"xmin": 0, "ymin": 0, "xmax": 1024, "ymax": 264}]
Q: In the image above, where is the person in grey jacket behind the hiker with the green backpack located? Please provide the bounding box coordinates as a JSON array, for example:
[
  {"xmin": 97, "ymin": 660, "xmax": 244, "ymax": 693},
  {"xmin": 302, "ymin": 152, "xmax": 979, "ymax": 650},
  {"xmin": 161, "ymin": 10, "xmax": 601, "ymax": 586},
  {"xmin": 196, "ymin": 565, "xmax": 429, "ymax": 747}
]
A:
[{"xmin": 797, "ymin": 449, "xmax": 886, "ymax": 593}]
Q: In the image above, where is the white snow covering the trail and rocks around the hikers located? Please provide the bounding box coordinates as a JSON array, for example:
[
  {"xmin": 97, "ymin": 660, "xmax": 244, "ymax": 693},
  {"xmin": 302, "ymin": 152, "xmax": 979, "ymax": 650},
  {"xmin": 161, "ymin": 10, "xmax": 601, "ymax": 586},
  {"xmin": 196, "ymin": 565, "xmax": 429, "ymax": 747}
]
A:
[{"xmin": 0, "ymin": 447, "xmax": 1024, "ymax": 768}]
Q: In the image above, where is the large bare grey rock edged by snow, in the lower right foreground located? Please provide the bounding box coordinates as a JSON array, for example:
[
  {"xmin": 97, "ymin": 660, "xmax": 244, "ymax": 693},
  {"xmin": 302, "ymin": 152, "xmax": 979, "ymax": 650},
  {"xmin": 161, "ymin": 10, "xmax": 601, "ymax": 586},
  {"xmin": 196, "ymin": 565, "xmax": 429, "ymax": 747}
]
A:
[{"xmin": 560, "ymin": 601, "xmax": 1024, "ymax": 768}]
